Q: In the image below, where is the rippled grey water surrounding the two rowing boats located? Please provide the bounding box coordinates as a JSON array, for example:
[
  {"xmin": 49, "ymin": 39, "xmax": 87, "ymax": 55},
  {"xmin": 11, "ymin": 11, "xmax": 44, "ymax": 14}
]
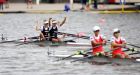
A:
[{"xmin": 0, "ymin": 12, "xmax": 140, "ymax": 75}]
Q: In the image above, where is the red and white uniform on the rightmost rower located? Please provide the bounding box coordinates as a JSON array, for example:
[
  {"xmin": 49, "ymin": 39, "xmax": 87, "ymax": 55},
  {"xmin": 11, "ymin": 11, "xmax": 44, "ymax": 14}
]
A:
[{"xmin": 111, "ymin": 37, "xmax": 126, "ymax": 57}]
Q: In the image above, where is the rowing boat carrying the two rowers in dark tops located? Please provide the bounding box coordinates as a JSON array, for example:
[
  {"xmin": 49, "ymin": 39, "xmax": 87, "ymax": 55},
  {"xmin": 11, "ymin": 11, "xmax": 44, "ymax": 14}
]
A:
[{"xmin": 0, "ymin": 36, "xmax": 91, "ymax": 46}]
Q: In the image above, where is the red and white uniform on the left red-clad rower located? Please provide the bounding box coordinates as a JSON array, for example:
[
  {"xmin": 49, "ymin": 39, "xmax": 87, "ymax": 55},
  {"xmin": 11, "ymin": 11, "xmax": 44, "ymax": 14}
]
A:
[{"xmin": 90, "ymin": 35, "xmax": 105, "ymax": 55}]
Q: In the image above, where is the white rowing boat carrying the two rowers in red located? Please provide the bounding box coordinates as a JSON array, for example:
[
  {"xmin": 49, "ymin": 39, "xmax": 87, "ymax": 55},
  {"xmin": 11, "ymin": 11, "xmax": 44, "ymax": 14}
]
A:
[{"xmin": 50, "ymin": 55, "xmax": 140, "ymax": 65}]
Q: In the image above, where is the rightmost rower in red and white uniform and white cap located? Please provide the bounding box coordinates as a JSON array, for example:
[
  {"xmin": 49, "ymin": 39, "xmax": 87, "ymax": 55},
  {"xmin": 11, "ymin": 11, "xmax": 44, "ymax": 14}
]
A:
[{"xmin": 111, "ymin": 28, "xmax": 128, "ymax": 58}]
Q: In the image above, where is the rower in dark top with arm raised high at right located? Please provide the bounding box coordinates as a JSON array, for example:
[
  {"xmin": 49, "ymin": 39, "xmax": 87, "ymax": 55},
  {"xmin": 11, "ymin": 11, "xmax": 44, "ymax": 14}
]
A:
[{"xmin": 49, "ymin": 17, "xmax": 66, "ymax": 42}]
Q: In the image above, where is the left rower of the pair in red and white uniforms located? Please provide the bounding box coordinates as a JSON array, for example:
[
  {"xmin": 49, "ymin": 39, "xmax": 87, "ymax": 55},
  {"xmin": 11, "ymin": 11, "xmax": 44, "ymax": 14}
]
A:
[{"xmin": 90, "ymin": 26, "xmax": 106, "ymax": 56}]
